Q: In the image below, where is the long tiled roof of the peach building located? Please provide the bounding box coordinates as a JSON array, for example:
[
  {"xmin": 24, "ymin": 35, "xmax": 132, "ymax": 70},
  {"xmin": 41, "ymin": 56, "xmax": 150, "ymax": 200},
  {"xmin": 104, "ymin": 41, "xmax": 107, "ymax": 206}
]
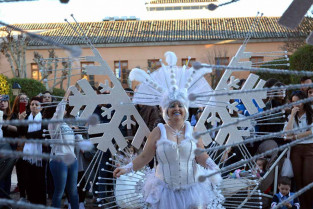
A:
[{"xmin": 0, "ymin": 17, "xmax": 313, "ymax": 46}]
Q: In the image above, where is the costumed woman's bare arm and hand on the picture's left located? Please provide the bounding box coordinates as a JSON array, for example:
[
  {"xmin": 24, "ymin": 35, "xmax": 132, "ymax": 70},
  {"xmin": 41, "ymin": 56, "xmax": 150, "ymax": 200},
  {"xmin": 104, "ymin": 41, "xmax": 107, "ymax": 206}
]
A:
[{"xmin": 113, "ymin": 127, "xmax": 161, "ymax": 177}]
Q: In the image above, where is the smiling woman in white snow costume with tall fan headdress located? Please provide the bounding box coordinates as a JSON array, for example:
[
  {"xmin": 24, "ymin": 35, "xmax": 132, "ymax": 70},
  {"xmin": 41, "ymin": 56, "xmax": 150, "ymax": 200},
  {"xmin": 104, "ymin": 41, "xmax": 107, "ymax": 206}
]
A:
[{"xmin": 113, "ymin": 52, "xmax": 224, "ymax": 209}]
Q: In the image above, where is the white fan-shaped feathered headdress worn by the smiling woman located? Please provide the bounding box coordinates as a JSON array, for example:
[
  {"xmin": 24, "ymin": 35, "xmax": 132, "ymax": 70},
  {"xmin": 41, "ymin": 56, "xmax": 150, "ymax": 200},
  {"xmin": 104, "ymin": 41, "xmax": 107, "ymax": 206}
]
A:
[{"xmin": 129, "ymin": 51, "xmax": 212, "ymax": 109}]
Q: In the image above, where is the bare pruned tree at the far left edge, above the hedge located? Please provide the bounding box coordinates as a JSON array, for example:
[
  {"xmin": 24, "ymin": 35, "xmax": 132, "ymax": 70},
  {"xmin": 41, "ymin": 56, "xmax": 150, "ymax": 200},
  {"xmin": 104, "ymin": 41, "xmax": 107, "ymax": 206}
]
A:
[{"xmin": 0, "ymin": 29, "xmax": 29, "ymax": 78}]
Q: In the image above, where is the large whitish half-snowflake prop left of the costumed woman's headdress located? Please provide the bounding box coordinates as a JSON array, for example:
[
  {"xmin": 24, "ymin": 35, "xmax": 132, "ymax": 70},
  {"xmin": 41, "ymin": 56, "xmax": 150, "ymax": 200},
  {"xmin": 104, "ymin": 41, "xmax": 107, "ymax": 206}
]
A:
[{"xmin": 69, "ymin": 48, "xmax": 150, "ymax": 154}]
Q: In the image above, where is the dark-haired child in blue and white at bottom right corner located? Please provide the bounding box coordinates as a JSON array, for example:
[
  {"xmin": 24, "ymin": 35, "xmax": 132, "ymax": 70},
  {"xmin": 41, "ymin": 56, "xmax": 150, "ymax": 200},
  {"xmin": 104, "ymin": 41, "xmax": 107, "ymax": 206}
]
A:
[{"xmin": 271, "ymin": 176, "xmax": 300, "ymax": 209}]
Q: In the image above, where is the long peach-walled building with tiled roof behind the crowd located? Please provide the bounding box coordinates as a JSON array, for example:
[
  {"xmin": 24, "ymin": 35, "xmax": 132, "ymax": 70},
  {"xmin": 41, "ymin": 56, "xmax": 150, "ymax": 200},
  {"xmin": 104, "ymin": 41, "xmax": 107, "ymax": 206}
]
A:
[{"xmin": 0, "ymin": 17, "xmax": 313, "ymax": 87}]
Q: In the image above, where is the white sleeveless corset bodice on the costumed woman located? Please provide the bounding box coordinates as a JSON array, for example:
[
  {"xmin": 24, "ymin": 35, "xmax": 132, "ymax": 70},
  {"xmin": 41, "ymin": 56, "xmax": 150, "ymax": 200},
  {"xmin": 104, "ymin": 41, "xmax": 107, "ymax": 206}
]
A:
[{"xmin": 155, "ymin": 122, "xmax": 197, "ymax": 189}]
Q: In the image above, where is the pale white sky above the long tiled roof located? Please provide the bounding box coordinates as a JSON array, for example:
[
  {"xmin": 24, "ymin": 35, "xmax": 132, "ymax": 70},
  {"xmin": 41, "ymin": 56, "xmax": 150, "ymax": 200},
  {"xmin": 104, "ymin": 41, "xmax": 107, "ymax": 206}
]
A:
[{"xmin": 0, "ymin": 0, "xmax": 298, "ymax": 24}]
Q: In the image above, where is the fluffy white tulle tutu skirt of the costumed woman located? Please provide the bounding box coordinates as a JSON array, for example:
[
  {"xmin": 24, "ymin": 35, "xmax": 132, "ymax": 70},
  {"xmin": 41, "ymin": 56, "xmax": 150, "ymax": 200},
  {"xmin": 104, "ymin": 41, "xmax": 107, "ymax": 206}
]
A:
[{"xmin": 143, "ymin": 169, "xmax": 224, "ymax": 209}]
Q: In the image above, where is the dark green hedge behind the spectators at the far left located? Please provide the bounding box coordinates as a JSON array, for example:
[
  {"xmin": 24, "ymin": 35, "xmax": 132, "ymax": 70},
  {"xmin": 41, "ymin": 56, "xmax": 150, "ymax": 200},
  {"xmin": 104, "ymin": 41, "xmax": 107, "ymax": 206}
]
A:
[{"xmin": 9, "ymin": 78, "xmax": 46, "ymax": 102}]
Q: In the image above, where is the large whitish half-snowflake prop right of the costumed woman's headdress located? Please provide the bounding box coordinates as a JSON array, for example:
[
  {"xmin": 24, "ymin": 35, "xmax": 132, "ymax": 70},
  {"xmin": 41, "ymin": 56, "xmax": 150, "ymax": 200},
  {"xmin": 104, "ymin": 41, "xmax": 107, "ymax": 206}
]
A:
[{"xmin": 196, "ymin": 44, "xmax": 266, "ymax": 146}]
